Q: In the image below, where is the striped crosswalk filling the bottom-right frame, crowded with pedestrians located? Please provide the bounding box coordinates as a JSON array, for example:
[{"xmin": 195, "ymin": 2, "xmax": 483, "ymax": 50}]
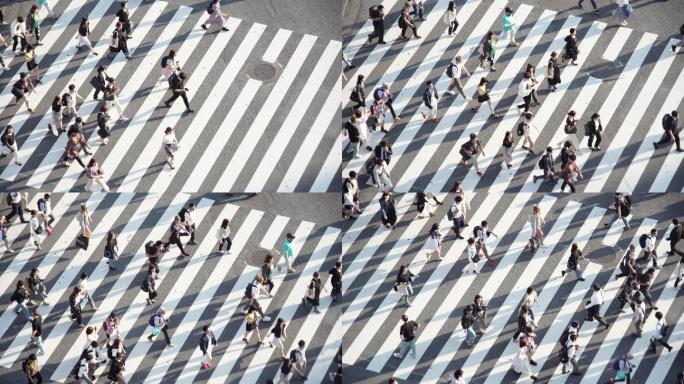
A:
[{"xmin": 342, "ymin": 192, "xmax": 684, "ymax": 383}]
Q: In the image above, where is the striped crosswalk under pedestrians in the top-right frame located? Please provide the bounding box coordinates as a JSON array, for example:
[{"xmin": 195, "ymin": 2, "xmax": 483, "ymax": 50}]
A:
[{"xmin": 339, "ymin": 0, "xmax": 684, "ymax": 193}]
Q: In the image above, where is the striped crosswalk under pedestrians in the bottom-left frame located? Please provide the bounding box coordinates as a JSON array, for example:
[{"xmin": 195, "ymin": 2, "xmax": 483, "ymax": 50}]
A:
[{"xmin": 0, "ymin": 193, "xmax": 340, "ymax": 383}]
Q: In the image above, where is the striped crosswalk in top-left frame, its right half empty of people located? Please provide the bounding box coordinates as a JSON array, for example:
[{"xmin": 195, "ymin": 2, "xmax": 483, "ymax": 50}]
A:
[{"xmin": 0, "ymin": 0, "xmax": 341, "ymax": 193}]
